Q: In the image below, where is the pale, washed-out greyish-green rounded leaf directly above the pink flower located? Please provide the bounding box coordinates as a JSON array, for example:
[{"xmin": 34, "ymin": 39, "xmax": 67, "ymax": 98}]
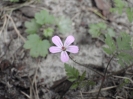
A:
[{"xmin": 57, "ymin": 16, "xmax": 72, "ymax": 33}]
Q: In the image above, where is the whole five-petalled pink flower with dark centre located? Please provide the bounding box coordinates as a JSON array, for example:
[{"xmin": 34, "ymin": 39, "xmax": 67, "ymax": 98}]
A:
[{"xmin": 49, "ymin": 35, "xmax": 79, "ymax": 62}]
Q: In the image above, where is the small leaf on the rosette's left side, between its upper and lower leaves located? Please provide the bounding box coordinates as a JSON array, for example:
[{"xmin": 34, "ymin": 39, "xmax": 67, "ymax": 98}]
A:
[{"xmin": 25, "ymin": 19, "xmax": 40, "ymax": 34}]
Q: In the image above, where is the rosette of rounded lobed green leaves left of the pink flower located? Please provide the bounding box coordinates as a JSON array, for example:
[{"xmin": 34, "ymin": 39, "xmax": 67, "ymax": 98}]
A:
[{"xmin": 24, "ymin": 10, "xmax": 72, "ymax": 57}]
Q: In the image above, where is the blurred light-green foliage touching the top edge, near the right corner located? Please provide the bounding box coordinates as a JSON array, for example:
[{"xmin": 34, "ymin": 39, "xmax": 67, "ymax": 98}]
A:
[{"xmin": 111, "ymin": 0, "xmax": 125, "ymax": 14}]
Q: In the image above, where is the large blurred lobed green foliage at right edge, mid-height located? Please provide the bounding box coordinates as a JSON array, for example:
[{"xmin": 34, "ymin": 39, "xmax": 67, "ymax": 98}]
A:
[{"xmin": 103, "ymin": 33, "xmax": 133, "ymax": 66}]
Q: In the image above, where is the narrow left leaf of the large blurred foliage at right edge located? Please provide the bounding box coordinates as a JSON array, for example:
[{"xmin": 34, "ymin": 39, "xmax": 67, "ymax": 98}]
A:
[{"xmin": 103, "ymin": 34, "xmax": 116, "ymax": 54}]
